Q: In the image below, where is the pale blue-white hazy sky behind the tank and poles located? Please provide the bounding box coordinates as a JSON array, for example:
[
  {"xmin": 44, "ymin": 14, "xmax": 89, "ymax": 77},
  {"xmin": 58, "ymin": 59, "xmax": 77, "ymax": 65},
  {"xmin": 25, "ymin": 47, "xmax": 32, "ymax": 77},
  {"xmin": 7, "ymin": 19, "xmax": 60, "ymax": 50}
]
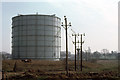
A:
[{"xmin": 0, "ymin": 0, "xmax": 119, "ymax": 53}]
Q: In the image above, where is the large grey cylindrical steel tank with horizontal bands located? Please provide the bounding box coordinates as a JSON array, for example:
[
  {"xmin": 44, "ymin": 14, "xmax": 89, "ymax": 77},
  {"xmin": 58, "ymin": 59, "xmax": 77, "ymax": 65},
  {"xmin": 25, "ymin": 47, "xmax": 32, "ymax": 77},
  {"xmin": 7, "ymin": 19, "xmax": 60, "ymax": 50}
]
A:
[{"xmin": 12, "ymin": 14, "xmax": 61, "ymax": 59}]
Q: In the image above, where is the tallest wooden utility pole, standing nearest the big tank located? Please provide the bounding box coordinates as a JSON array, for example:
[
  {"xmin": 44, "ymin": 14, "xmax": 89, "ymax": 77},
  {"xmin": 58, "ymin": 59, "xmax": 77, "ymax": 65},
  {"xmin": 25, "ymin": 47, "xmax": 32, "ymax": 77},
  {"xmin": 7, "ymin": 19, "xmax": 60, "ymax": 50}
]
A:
[{"xmin": 61, "ymin": 16, "xmax": 71, "ymax": 76}]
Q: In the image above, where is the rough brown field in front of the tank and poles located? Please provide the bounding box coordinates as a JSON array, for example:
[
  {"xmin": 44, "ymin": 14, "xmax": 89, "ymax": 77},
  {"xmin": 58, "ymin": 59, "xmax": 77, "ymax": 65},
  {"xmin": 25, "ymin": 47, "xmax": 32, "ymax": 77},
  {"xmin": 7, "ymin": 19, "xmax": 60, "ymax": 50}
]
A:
[{"xmin": 2, "ymin": 60, "xmax": 119, "ymax": 80}]
